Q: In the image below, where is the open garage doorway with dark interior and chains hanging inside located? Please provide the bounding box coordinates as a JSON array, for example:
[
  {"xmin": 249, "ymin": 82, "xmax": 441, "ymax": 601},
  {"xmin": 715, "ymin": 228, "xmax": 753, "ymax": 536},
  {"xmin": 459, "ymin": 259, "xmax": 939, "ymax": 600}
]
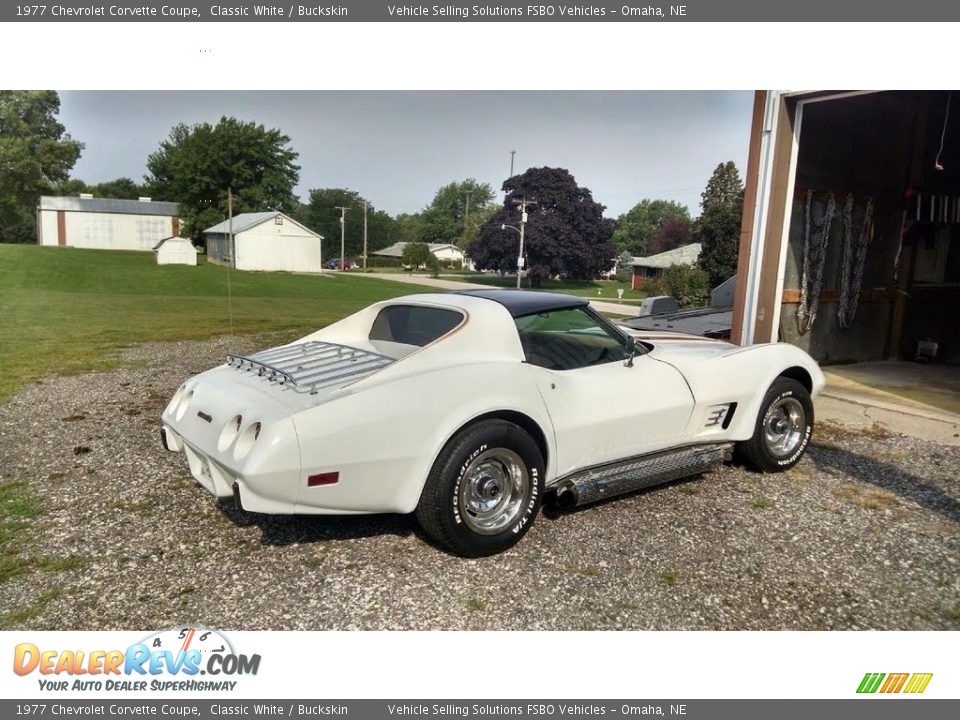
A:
[{"xmin": 734, "ymin": 90, "xmax": 960, "ymax": 416}]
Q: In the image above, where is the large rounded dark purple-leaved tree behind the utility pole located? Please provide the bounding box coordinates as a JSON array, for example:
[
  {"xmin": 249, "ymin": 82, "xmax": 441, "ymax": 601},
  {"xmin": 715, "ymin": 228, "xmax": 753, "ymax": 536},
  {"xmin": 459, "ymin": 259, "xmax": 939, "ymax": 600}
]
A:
[{"xmin": 468, "ymin": 167, "xmax": 616, "ymax": 287}]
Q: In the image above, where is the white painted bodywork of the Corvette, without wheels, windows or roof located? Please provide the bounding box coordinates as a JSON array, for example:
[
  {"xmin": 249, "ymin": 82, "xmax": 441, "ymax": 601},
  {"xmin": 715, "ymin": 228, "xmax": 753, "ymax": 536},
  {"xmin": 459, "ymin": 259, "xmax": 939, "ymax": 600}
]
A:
[{"xmin": 162, "ymin": 293, "xmax": 824, "ymax": 514}]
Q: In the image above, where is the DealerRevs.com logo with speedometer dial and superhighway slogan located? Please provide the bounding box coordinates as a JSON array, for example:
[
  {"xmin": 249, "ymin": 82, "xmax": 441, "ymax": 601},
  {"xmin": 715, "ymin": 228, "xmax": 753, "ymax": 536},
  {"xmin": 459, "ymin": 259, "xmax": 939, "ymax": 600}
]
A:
[{"xmin": 13, "ymin": 627, "xmax": 260, "ymax": 692}]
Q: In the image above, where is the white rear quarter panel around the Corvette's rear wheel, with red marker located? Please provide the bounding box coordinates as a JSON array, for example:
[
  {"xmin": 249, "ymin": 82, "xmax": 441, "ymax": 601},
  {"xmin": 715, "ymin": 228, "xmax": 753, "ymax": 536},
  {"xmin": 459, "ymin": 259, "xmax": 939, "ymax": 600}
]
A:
[{"xmin": 293, "ymin": 361, "xmax": 553, "ymax": 513}]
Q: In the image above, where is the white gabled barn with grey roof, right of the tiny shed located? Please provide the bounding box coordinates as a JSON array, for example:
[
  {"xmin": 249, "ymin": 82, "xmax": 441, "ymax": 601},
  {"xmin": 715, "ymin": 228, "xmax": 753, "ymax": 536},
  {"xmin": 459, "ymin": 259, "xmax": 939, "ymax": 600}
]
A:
[{"xmin": 203, "ymin": 210, "xmax": 323, "ymax": 272}]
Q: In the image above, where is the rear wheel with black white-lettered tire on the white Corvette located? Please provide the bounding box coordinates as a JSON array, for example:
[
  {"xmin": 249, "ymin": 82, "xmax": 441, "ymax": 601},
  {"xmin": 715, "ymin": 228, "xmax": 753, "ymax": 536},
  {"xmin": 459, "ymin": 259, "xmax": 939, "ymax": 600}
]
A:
[{"xmin": 416, "ymin": 420, "xmax": 544, "ymax": 557}]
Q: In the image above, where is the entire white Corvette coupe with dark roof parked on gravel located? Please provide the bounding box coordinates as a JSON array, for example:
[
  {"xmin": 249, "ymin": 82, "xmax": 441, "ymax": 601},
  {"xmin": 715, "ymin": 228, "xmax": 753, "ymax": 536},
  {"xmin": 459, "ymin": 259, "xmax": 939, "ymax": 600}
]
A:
[{"xmin": 163, "ymin": 290, "xmax": 824, "ymax": 557}]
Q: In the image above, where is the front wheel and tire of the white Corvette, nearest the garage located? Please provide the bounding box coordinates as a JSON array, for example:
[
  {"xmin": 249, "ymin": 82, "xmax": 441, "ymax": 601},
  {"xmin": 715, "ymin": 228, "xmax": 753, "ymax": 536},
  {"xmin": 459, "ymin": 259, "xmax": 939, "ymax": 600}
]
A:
[{"xmin": 737, "ymin": 377, "xmax": 813, "ymax": 472}]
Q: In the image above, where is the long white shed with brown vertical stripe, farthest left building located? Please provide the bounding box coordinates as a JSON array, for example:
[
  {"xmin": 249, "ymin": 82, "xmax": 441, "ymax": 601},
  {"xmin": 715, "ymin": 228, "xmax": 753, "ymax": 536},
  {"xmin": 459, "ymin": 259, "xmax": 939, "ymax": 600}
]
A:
[{"xmin": 37, "ymin": 194, "xmax": 180, "ymax": 251}]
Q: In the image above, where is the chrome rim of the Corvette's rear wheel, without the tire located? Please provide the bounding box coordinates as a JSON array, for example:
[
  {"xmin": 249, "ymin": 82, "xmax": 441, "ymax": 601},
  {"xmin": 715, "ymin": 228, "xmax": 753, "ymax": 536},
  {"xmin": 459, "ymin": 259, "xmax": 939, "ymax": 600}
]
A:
[{"xmin": 457, "ymin": 448, "xmax": 531, "ymax": 535}]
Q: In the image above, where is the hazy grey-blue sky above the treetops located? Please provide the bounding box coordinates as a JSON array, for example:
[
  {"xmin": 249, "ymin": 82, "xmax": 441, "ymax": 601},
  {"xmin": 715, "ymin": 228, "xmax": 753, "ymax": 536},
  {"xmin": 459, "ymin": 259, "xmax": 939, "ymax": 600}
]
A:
[{"xmin": 60, "ymin": 91, "xmax": 753, "ymax": 217}]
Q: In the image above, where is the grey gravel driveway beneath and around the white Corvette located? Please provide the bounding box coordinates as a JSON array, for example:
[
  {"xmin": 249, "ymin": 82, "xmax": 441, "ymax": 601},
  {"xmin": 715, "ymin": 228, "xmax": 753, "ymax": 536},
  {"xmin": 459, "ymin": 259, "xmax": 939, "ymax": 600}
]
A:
[{"xmin": 0, "ymin": 337, "xmax": 960, "ymax": 630}]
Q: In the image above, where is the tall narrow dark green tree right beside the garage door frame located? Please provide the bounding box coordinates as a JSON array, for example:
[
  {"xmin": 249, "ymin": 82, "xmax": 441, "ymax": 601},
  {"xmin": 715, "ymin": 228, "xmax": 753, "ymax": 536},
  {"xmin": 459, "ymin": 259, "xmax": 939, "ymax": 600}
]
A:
[{"xmin": 694, "ymin": 161, "xmax": 743, "ymax": 287}]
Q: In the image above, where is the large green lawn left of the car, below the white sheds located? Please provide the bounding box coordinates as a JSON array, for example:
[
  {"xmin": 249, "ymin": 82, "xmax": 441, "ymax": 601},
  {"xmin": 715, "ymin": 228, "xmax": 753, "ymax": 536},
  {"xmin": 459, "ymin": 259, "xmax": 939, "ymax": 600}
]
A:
[{"xmin": 0, "ymin": 244, "xmax": 423, "ymax": 402}]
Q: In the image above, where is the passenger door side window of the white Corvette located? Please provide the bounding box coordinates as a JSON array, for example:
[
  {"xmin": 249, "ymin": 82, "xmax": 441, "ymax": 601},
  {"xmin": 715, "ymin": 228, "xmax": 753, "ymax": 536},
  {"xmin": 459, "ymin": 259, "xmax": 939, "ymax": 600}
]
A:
[{"xmin": 515, "ymin": 307, "xmax": 629, "ymax": 370}]
